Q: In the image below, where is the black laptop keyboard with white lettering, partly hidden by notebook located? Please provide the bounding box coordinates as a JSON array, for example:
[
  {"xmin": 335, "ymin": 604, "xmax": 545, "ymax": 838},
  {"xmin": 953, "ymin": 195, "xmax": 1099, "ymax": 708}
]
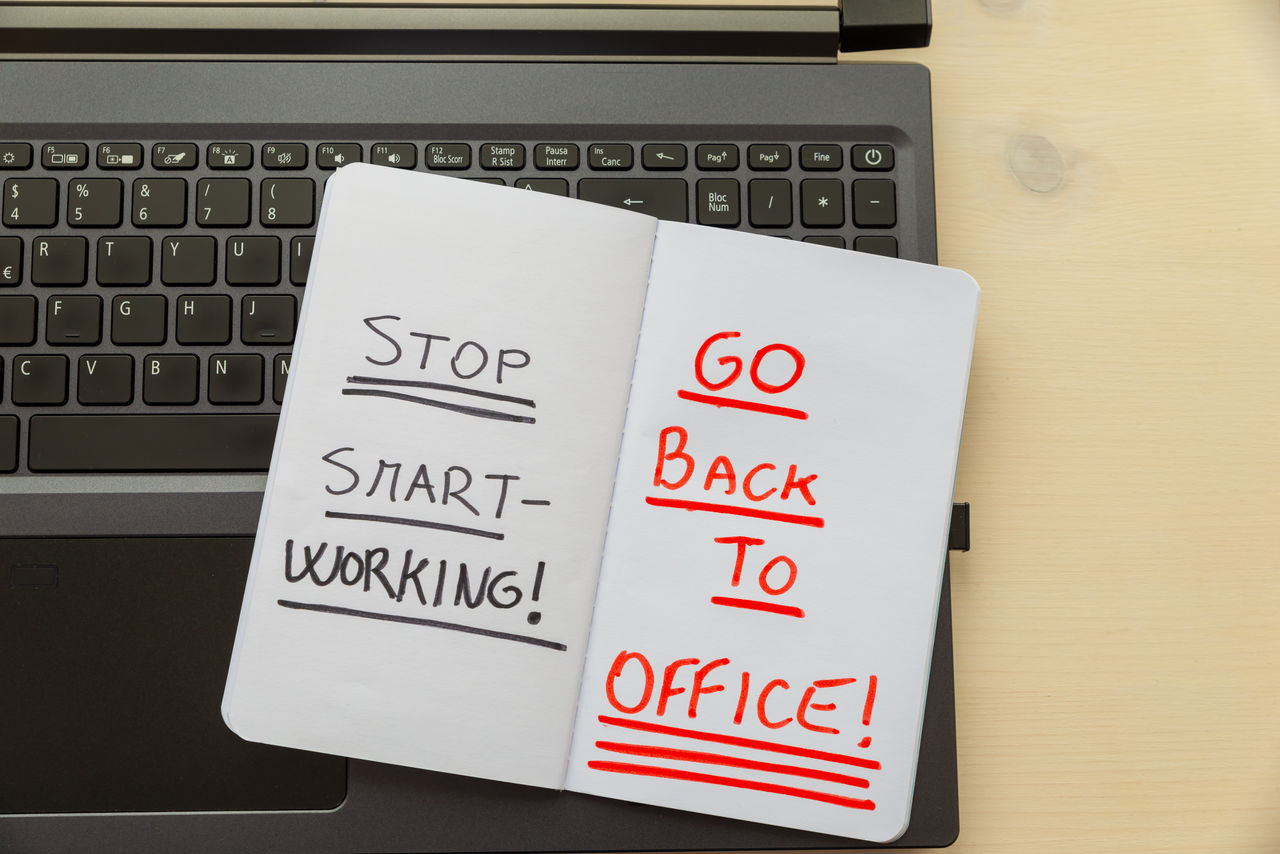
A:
[{"xmin": 0, "ymin": 136, "xmax": 902, "ymax": 474}]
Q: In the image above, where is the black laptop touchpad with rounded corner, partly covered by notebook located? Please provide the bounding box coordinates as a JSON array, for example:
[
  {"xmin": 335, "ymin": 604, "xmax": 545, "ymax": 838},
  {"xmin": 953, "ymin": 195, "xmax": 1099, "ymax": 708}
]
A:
[{"xmin": 0, "ymin": 538, "xmax": 347, "ymax": 814}]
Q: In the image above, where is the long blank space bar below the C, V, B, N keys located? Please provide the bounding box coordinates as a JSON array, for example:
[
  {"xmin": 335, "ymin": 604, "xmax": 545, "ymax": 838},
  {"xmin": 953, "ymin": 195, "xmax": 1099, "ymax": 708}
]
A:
[{"xmin": 28, "ymin": 414, "xmax": 276, "ymax": 471}]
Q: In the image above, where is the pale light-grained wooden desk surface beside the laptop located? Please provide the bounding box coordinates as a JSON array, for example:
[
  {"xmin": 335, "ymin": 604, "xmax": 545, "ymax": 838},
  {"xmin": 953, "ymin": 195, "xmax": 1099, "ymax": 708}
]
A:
[{"xmin": 829, "ymin": 0, "xmax": 1280, "ymax": 854}]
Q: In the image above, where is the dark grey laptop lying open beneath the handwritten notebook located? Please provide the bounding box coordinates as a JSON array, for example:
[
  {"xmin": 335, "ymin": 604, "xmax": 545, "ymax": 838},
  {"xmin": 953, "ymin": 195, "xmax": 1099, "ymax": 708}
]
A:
[{"xmin": 0, "ymin": 0, "xmax": 964, "ymax": 853}]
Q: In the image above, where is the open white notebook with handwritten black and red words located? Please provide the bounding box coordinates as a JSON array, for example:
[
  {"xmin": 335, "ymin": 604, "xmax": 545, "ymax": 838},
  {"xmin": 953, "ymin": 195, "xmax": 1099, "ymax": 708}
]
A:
[{"xmin": 223, "ymin": 165, "xmax": 978, "ymax": 841}]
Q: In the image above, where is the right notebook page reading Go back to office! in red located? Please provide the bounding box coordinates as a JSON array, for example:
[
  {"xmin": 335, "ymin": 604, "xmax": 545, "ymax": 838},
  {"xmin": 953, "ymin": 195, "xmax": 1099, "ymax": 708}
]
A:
[{"xmin": 566, "ymin": 223, "xmax": 978, "ymax": 841}]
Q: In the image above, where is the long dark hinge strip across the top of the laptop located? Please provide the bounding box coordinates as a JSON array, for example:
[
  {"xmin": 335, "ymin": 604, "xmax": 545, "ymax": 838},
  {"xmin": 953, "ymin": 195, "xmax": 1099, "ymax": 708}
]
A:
[{"xmin": 0, "ymin": 0, "xmax": 840, "ymax": 61}]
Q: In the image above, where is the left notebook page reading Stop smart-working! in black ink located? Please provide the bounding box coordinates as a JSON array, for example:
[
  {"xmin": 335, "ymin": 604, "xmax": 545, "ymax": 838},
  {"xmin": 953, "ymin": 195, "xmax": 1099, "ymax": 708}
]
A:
[{"xmin": 223, "ymin": 165, "xmax": 655, "ymax": 787}]
